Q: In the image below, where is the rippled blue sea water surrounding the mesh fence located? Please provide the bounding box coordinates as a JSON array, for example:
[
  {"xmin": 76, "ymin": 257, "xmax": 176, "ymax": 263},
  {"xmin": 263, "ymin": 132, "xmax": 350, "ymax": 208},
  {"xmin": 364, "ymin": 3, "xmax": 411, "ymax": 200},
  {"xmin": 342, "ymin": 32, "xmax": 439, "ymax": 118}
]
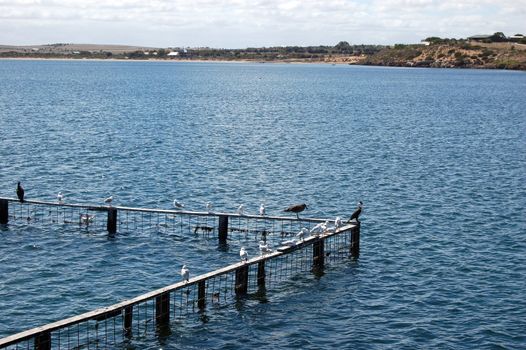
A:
[{"xmin": 0, "ymin": 60, "xmax": 526, "ymax": 349}]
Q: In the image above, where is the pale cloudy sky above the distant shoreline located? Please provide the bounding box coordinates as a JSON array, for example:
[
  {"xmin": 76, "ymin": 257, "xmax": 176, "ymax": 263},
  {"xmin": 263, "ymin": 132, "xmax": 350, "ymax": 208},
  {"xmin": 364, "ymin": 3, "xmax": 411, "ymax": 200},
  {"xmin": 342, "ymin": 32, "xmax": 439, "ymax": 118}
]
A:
[{"xmin": 0, "ymin": 0, "xmax": 526, "ymax": 48}]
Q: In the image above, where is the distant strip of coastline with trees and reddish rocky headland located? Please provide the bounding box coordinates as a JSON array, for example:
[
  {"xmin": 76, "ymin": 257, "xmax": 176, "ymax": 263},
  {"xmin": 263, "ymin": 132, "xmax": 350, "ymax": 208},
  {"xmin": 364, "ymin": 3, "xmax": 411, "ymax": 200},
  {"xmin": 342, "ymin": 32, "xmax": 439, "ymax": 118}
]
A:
[{"xmin": 0, "ymin": 37, "xmax": 526, "ymax": 70}]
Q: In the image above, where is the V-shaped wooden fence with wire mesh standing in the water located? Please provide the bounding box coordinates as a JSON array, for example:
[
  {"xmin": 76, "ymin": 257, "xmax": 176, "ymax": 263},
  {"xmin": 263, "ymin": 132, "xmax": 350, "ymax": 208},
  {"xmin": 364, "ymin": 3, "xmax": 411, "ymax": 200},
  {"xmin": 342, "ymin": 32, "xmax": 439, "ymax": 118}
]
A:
[{"xmin": 0, "ymin": 198, "xmax": 360, "ymax": 350}]
